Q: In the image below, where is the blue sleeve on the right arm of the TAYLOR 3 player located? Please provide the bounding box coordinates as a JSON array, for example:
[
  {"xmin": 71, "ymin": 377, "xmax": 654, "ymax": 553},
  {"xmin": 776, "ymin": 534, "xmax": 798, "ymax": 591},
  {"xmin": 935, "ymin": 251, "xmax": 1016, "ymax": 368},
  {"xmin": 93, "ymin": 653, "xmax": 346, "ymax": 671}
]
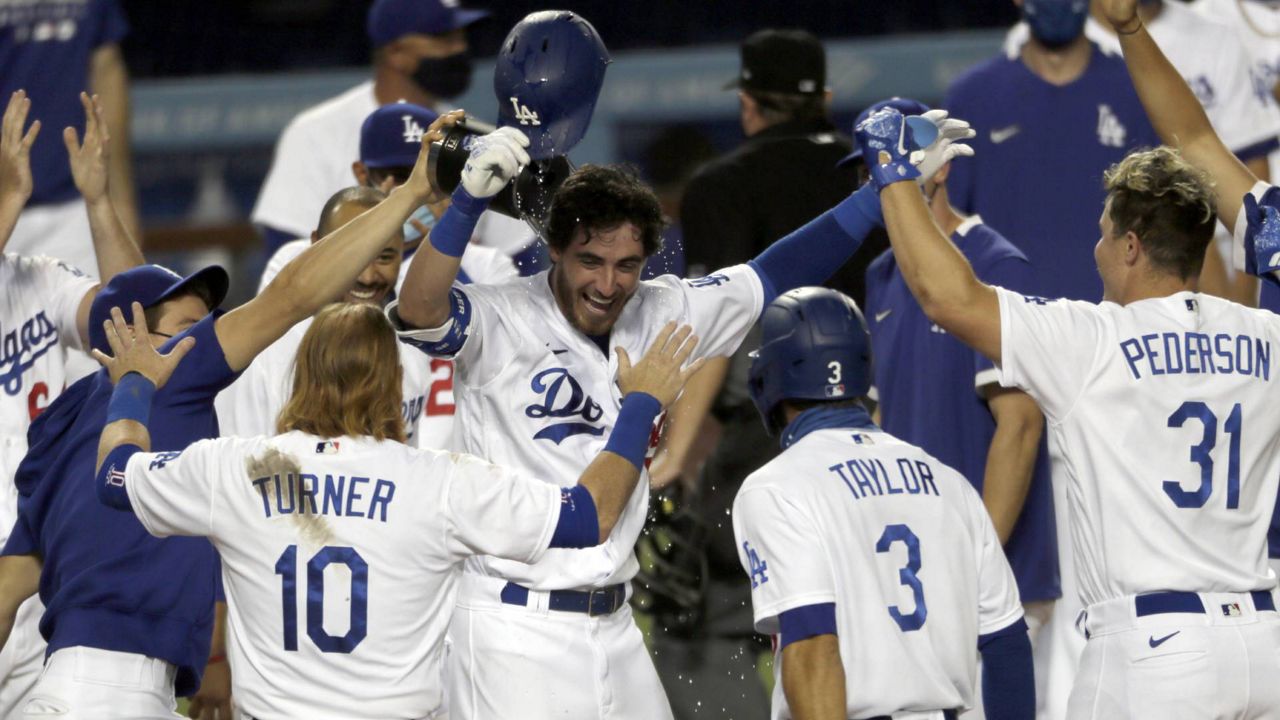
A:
[{"xmin": 978, "ymin": 618, "xmax": 1036, "ymax": 720}]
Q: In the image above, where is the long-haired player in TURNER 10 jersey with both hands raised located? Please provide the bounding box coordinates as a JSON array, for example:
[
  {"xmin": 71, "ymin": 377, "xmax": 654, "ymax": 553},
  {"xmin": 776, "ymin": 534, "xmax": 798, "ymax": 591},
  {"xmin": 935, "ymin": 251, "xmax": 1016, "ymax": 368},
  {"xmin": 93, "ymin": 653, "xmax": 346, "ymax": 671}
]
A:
[{"xmin": 97, "ymin": 299, "xmax": 698, "ymax": 720}]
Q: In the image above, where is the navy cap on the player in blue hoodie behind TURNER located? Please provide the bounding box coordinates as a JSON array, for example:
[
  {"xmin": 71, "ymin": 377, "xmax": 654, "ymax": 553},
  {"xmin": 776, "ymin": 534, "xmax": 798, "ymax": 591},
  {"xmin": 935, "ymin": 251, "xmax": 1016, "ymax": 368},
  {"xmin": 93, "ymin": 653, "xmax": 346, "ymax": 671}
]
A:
[{"xmin": 88, "ymin": 265, "xmax": 230, "ymax": 354}]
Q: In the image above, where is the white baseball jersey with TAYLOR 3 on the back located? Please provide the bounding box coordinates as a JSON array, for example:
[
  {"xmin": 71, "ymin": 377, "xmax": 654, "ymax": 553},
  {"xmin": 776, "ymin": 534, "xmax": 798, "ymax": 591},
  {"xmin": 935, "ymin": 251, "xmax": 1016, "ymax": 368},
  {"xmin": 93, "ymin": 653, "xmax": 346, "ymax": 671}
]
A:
[{"xmin": 733, "ymin": 428, "xmax": 1023, "ymax": 719}]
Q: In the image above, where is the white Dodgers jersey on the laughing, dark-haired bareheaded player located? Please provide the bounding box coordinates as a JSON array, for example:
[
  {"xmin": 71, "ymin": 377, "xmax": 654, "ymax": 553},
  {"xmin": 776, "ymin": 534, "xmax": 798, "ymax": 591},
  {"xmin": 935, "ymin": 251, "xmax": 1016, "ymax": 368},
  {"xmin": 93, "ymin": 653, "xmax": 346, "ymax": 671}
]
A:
[{"xmin": 388, "ymin": 265, "xmax": 764, "ymax": 589}]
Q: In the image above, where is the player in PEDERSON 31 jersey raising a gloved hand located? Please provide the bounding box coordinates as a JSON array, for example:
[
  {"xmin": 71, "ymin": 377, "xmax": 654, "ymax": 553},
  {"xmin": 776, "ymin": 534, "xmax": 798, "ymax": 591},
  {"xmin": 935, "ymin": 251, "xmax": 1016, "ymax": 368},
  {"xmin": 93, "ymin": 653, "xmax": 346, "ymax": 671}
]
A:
[{"xmin": 858, "ymin": 51, "xmax": 1280, "ymax": 719}]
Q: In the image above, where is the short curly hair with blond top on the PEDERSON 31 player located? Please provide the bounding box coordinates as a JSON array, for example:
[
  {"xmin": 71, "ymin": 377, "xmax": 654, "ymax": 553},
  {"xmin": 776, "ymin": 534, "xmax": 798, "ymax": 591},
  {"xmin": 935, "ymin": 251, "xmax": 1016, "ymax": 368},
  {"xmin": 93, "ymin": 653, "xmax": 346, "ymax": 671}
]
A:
[{"xmin": 1102, "ymin": 146, "xmax": 1217, "ymax": 281}]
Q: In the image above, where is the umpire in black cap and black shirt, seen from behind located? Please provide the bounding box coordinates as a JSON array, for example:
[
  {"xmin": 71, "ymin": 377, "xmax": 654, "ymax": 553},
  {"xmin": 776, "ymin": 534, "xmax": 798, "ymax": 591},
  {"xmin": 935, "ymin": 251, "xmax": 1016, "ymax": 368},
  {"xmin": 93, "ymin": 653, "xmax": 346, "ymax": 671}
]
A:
[{"xmin": 641, "ymin": 29, "xmax": 886, "ymax": 720}]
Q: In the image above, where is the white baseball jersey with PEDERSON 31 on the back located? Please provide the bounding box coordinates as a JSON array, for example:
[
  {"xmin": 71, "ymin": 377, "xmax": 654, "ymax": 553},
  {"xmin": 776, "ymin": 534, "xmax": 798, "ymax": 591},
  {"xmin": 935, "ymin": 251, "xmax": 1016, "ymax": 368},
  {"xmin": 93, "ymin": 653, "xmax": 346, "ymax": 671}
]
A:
[{"xmin": 997, "ymin": 288, "xmax": 1280, "ymax": 606}]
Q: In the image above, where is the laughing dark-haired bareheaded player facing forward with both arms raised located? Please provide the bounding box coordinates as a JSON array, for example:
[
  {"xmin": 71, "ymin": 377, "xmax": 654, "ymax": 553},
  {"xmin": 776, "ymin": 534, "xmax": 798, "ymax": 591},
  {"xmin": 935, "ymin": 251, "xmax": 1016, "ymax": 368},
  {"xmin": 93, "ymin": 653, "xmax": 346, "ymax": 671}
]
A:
[{"xmin": 388, "ymin": 13, "xmax": 962, "ymax": 717}]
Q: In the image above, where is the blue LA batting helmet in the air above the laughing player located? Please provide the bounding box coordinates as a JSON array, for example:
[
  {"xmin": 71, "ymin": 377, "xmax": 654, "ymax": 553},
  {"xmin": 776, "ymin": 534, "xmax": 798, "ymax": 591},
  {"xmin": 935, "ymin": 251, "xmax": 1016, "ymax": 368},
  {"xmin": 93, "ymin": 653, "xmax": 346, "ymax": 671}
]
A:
[{"xmin": 493, "ymin": 10, "xmax": 609, "ymax": 160}]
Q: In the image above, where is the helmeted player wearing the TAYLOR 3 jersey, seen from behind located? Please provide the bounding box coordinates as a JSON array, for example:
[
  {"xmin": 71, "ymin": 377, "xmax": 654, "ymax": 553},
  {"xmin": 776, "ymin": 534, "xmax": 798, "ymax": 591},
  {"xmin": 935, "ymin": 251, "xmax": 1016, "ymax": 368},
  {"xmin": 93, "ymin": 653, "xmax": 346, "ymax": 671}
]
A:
[{"xmin": 733, "ymin": 288, "xmax": 1036, "ymax": 720}]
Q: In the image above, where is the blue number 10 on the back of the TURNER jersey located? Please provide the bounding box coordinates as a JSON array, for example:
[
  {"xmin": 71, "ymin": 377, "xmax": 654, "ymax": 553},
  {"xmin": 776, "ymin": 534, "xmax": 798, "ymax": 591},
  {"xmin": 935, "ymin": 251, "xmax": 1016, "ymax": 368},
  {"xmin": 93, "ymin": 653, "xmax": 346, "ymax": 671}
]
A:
[{"xmin": 275, "ymin": 544, "xmax": 369, "ymax": 653}]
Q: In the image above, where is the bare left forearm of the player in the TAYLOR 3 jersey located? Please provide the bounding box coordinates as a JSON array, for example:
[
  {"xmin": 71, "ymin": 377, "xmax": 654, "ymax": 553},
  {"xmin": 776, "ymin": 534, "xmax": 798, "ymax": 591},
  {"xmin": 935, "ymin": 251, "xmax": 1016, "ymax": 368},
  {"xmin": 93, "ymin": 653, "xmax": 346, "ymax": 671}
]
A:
[{"xmin": 782, "ymin": 635, "xmax": 849, "ymax": 720}]
